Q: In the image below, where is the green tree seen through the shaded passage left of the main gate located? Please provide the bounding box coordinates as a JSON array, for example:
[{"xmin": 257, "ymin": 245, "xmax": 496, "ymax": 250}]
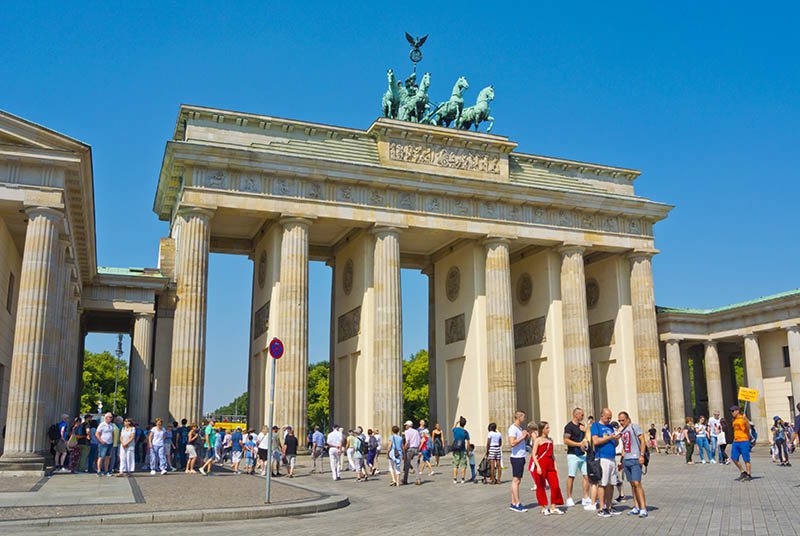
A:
[{"xmin": 81, "ymin": 350, "xmax": 128, "ymax": 415}]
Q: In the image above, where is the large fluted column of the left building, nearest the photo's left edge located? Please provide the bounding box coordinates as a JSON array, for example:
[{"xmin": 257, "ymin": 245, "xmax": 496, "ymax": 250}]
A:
[{"xmin": 0, "ymin": 207, "xmax": 63, "ymax": 472}]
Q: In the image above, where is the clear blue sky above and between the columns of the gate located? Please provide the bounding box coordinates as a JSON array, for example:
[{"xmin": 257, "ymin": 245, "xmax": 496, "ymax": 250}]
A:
[{"xmin": 0, "ymin": 0, "xmax": 800, "ymax": 409}]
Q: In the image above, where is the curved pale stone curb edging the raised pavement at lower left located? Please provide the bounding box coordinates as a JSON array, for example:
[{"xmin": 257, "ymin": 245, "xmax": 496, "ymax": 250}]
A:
[{"xmin": 0, "ymin": 495, "xmax": 350, "ymax": 529}]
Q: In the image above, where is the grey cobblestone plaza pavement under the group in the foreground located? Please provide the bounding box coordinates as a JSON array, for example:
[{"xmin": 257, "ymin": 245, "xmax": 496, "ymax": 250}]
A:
[{"xmin": 9, "ymin": 448, "xmax": 800, "ymax": 536}]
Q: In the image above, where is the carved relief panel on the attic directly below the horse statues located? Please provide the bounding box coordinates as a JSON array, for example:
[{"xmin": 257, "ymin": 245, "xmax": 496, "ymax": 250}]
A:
[{"xmin": 389, "ymin": 141, "xmax": 500, "ymax": 174}]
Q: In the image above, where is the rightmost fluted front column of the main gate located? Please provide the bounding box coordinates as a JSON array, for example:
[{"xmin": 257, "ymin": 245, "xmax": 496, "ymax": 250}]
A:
[{"xmin": 630, "ymin": 251, "xmax": 664, "ymax": 426}]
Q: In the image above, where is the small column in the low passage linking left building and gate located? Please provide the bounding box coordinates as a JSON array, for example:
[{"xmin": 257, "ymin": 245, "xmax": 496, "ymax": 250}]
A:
[{"xmin": 128, "ymin": 313, "xmax": 155, "ymax": 424}]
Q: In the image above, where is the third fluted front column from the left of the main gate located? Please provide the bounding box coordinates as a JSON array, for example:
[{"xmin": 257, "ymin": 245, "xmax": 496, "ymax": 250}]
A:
[{"xmin": 372, "ymin": 227, "xmax": 403, "ymax": 437}]
